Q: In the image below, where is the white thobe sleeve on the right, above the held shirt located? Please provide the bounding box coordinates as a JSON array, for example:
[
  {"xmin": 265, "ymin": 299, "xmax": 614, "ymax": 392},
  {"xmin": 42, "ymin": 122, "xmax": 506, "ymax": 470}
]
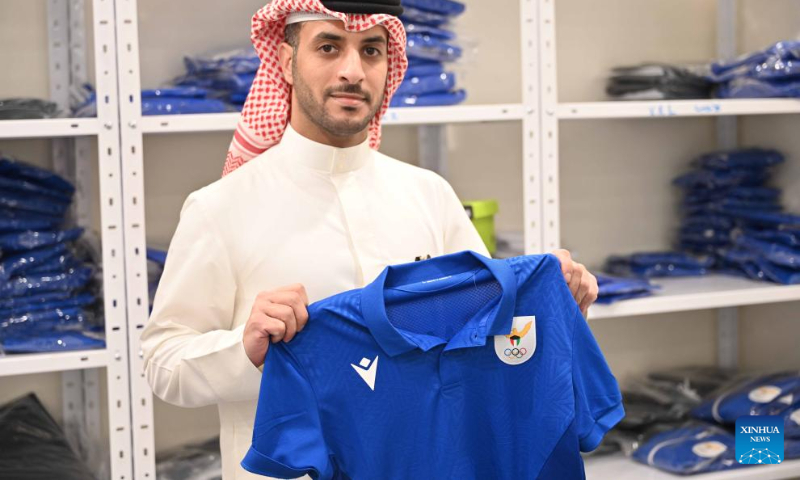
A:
[{"xmin": 438, "ymin": 177, "xmax": 491, "ymax": 257}]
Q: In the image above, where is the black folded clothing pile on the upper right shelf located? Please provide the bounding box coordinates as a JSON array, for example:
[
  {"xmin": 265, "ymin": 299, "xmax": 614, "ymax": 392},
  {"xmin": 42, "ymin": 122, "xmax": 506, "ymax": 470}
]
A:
[{"xmin": 606, "ymin": 63, "xmax": 714, "ymax": 100}]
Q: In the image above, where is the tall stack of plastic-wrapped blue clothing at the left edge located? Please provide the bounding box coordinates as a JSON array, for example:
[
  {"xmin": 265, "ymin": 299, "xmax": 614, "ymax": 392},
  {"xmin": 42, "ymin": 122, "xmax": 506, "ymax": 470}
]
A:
[{"xmin": 0, "ymin": 156, "xmax": 105, "ymax": 353}]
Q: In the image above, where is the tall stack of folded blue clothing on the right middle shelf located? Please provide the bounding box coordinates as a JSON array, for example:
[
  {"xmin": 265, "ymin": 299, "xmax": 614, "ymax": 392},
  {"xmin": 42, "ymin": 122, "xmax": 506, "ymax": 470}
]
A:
[{"xmin": 674, "ymin": 148, "xmax": 800, "ymax": 284}]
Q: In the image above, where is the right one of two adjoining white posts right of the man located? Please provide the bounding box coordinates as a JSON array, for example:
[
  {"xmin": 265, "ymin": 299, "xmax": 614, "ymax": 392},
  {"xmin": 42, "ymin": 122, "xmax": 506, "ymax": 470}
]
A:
[{"xmin": 536, "ymin": 0, "xmax": 561, "ymax": 252}]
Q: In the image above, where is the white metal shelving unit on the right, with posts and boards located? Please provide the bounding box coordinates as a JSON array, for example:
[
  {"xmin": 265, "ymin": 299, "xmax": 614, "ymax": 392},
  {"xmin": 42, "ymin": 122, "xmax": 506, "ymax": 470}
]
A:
[{"xmin": 538, "ymin": 0, "xmax": 800, "ymax": 480}]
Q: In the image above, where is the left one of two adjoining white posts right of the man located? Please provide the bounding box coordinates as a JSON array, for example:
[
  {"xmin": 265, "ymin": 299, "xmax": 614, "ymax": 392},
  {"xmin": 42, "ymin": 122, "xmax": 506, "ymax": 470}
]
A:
[{"xmin": 519, "ymin": 0, "xmax": 544, "ymax": 251}]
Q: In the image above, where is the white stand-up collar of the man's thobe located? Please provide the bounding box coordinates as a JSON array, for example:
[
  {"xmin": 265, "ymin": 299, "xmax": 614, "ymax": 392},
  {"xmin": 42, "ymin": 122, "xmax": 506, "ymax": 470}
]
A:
[{"xmin": 280, "ymin": 125, "xmax": 372, "ymax": 175}]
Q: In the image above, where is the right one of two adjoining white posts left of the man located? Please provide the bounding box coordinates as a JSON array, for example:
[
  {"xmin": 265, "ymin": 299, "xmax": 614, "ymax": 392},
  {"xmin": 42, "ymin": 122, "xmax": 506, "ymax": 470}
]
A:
[{"xmin": 115, "ymin": 0, "xmax": 156, "ymax": 480}]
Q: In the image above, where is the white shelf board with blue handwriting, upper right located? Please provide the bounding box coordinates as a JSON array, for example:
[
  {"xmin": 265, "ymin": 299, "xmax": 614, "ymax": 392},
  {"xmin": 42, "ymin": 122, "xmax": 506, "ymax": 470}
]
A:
[{"xmin": 557, "ymin": 98, "xmax": 800, "ymax": 120}]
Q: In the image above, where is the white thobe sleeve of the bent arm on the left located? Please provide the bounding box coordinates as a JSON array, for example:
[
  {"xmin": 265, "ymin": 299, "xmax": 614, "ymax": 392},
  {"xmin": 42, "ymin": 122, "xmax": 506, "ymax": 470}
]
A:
[{"xmin": 141, "ymin": 192, "xmax": 261, "ymax": 407}]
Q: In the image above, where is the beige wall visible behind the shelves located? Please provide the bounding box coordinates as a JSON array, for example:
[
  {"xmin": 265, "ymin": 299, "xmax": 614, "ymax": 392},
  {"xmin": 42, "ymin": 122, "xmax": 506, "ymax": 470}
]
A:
[{"xmin": 0, "ymin": 0, "xmax": 800, "ymax": 458}]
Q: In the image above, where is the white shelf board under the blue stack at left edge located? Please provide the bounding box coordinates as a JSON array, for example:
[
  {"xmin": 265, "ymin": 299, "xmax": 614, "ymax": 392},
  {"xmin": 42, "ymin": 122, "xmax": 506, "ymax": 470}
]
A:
[{"xmin": 0, "ymin": 349, "xmax": 110, "ymax": 377}]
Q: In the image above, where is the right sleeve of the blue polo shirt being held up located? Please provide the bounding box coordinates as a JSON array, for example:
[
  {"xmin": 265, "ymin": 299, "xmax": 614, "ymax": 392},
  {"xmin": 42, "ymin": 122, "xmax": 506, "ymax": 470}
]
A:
[{"xmin": 572, "ymin": 310, "xmax": 625, "ymax": 452}]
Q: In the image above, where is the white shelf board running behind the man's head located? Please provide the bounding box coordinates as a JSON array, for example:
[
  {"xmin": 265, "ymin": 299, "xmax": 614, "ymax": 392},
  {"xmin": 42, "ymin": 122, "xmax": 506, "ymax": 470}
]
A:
[{"xmin": 142, "ymin": 104, "xmax": 524, "ymax": 133}]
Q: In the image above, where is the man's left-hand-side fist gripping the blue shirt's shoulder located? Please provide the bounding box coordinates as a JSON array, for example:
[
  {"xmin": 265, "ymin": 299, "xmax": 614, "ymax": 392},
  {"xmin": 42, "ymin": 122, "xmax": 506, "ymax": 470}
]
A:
[{"xmin": 242, "ymin": 284, "xmax": 308, "ymax": 367}]
